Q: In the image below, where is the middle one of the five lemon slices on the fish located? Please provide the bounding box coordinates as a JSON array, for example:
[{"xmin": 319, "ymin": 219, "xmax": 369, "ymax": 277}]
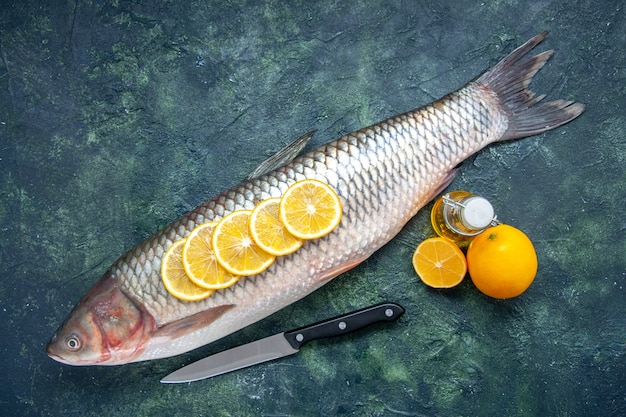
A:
[{"xmin": 211, "ymin": 210, "xmax": 276, "ymax": 275}]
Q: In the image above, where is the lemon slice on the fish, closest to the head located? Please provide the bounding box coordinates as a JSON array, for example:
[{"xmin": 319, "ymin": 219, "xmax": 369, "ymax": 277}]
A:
[{"xmin": 161, "ymin": 239, "xmax": 213, "ymax": 301}]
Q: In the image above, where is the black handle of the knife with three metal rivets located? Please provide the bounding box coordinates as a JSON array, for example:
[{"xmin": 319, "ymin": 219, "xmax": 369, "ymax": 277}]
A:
[{"xmin": 285, "ymin": 302, "xmax": 404, "ymax": 349}]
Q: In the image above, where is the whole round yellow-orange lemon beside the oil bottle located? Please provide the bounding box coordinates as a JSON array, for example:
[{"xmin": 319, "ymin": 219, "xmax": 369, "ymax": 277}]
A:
[{"xmin": 467, "ymin": 224, "xmax": 537, "ymax": 298}]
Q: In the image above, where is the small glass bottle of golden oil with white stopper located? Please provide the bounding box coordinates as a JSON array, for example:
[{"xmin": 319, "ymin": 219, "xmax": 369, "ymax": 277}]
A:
[{"xmin": 430, "ymin": 190, "xmax": 497, "ymax": 248}]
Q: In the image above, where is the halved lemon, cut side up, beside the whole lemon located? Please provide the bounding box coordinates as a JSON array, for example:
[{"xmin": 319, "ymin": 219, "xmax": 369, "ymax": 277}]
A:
[{"xmin": 413, "ymin": 237, "xmax": 467, "ymax": 288}]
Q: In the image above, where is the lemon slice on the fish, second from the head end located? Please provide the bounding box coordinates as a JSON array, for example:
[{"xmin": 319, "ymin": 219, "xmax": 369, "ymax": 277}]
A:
[{"xmin": 183, "ymin": 222, "xmax": 241, "ymax": 290}]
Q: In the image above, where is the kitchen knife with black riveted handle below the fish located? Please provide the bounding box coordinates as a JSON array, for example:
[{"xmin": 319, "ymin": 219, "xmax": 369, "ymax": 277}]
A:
[{"xmin": 161, "ymin": 302, "xmax": 404, "ymax": 384}]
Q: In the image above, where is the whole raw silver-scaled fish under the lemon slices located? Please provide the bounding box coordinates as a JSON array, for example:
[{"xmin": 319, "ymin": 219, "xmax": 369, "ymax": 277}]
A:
[{"xmin": 47, "ymin": 33, "xmax": 584, "ymax": 365}]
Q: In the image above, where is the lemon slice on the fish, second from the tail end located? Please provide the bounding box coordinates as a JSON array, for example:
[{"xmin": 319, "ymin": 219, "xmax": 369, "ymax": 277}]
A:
[{"xmin": 250, "ymin": 198, "xmax": 304, "ymax": 256}]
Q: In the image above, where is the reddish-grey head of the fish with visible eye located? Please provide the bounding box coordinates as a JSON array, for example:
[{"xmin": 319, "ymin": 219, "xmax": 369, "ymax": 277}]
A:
[{"xmin": 46, "ymin": 274, "xmax": 156, "ymax": 365}]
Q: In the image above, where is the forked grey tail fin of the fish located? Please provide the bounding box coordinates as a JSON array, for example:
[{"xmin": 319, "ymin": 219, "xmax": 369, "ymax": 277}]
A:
[{"xmin": 474, "ymin": 32, "xmax": 585, "ymax": 140}]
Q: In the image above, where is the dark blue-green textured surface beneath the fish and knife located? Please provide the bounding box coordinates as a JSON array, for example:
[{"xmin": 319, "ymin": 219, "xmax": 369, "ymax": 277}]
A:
[{"xmin": 0, "ymin": 0, "xmax": 626, "ymax": 416}]
